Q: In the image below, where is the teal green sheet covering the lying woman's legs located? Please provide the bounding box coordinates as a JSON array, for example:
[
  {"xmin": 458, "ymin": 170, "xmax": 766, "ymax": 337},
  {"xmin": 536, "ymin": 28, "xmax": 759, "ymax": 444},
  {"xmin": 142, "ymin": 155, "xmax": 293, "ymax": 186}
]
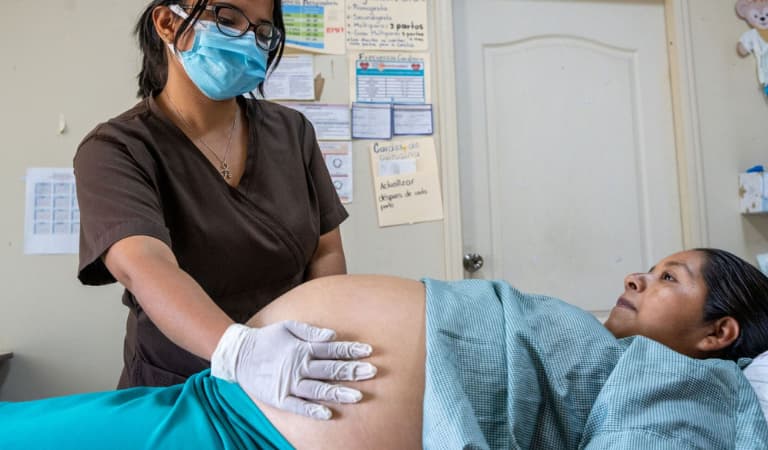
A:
[{"xmin": 0, "ymin": 371, "xmax": 293, "ymax": 450}]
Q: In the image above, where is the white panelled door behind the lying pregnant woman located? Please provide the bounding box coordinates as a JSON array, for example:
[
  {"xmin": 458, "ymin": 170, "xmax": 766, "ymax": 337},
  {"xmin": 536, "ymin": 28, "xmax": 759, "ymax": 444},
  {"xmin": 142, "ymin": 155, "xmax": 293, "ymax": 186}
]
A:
[{"xmin": 454, "ymin": 0, "xmax": 682, "ymax": 315}]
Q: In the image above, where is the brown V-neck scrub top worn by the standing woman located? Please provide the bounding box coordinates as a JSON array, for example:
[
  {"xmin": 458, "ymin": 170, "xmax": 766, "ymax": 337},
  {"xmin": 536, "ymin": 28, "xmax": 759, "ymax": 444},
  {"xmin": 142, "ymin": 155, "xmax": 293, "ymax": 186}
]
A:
[{"xmin": 74, "ymin": 97, "xmax": 347, "ymax": 387}]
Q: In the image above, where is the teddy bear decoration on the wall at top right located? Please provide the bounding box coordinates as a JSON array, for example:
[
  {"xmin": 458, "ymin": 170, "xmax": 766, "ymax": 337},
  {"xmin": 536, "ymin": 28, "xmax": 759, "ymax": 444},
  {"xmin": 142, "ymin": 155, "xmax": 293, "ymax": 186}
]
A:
[{"xmin": 736, "ymin": 0, "xmax": 768, "ymax": 95}]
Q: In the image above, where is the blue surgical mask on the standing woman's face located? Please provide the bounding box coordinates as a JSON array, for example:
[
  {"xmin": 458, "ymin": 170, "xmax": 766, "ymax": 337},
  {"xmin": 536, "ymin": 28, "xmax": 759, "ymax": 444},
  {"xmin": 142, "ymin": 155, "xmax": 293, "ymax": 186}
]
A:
[{"xmin": 168, "ymin": 5, "xmax": 268, "ymax": 100}]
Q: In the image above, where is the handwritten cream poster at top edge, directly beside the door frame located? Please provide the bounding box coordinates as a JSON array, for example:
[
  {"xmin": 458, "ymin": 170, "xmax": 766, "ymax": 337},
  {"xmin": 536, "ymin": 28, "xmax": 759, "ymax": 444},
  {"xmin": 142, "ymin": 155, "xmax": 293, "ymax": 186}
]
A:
[{"xmin": 347, "ymin": 0, "xmax": 429, "ymax": 51}]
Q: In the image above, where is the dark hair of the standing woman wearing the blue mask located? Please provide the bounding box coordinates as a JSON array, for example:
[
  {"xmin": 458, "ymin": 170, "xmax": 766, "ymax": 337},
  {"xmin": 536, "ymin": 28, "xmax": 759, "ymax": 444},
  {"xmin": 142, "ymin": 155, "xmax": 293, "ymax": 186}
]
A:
[{"xmin": 134, "ymin": 0, "xmax": 285, "ymax": 98}]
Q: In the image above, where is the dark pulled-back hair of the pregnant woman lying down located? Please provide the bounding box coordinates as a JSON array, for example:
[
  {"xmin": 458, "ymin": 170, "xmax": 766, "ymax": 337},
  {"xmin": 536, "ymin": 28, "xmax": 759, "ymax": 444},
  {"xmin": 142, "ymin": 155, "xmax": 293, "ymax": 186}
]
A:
[{"xmin": 695, "ymin": 248, "xmax": 768, "ymax": 360}]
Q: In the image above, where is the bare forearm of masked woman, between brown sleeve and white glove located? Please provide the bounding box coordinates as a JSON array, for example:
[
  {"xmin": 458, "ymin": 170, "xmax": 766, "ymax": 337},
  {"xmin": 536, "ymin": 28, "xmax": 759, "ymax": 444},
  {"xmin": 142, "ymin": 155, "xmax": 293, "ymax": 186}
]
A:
[{"xmin": 104, "ymin": 236, "xmax": 232, "ymax": 360}]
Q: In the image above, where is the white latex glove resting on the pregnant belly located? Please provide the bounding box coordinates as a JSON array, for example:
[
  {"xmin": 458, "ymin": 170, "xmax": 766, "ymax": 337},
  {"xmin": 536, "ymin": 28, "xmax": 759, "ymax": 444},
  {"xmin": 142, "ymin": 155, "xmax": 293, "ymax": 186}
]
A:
[{"xmin": 211, "ymin": 320, "xmax": 376, "ymax": 420}]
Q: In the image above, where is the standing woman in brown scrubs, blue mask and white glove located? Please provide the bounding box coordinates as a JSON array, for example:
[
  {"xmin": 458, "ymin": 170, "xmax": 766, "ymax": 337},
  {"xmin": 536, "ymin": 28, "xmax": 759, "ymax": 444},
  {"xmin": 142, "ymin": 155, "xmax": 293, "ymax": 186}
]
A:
[{"xmin": 74, "ymin": 0, "xmax": 376, "ymax": 419}]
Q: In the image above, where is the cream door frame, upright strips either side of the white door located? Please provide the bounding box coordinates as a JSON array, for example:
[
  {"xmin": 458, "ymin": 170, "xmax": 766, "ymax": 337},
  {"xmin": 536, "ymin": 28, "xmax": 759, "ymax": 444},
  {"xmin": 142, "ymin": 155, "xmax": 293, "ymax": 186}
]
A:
[{"xmin": 429, "ymin": 0, "xmax": 709, "ymax": 280}]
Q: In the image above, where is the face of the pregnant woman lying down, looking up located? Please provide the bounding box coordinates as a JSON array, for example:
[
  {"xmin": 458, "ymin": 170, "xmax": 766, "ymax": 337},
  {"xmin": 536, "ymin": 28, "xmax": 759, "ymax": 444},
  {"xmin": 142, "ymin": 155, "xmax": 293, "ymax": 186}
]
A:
[{"xmin": 605, "ymin": 251, "xmax": 709, "ymax": 357}]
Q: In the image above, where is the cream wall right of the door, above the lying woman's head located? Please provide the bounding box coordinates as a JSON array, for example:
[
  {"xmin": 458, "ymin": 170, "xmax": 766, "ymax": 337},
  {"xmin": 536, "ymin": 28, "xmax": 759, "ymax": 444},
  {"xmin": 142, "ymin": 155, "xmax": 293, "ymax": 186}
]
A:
[{"xmin": 689, "ymin": 0, "xmax": 768, "ymax": 256}]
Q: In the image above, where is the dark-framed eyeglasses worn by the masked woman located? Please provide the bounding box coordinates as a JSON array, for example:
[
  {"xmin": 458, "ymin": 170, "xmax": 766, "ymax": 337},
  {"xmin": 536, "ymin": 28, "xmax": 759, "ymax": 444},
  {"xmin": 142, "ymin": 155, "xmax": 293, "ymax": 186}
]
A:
[{"xmin": 180, "ymin": 3, "xmax": 282, "ymax": 52}]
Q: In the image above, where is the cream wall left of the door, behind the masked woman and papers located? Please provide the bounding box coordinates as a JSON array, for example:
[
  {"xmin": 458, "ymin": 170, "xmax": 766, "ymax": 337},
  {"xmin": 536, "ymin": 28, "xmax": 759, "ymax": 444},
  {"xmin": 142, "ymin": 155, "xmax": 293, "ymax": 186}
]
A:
[{"xmin": 0, "ymin": 0, "xmax": 444, "ymax": 401}]
